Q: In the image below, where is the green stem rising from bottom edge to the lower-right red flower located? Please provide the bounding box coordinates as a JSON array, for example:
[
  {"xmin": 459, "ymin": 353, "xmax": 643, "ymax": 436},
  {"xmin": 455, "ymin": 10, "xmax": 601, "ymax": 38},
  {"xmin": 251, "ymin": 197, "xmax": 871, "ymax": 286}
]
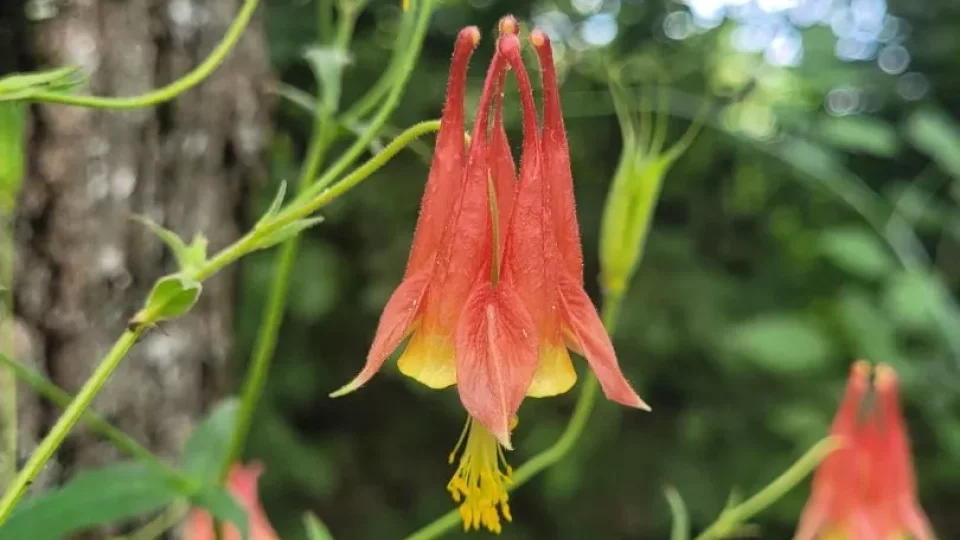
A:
[{"xmin": 694, "ymin": 437, "xmax": 839, "ymax": 540}]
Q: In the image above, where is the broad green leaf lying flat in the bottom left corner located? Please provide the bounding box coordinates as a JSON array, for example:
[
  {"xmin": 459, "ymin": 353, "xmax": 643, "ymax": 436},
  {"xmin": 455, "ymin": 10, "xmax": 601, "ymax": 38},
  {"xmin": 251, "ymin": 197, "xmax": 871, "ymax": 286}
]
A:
[{"xmin": 0, "ymin": 463, "xmax": 182, "ymax": 540}]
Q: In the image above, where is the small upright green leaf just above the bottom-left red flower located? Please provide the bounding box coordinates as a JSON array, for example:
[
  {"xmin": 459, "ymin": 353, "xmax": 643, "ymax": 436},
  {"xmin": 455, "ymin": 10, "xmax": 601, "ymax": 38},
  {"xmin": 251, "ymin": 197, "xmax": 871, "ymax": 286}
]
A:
[{"xmin": 183, "ymin": 398, "xmax": 240, "ymax": 485}]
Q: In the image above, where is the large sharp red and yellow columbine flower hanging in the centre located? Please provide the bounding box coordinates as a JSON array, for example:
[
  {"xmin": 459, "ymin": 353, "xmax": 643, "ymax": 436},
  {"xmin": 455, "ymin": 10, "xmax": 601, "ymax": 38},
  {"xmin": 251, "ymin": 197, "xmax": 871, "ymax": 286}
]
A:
[{"xmin": 333, "ymin": 17, "xmax": 648, "ymax": 532}]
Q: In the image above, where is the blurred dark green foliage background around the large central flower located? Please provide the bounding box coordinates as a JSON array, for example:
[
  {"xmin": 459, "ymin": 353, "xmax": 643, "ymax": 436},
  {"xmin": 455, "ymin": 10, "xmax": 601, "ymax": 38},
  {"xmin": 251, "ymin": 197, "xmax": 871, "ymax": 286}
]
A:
[{"xmin": 236, "ymin": 0, "xmax": 960, "ymax": 539}]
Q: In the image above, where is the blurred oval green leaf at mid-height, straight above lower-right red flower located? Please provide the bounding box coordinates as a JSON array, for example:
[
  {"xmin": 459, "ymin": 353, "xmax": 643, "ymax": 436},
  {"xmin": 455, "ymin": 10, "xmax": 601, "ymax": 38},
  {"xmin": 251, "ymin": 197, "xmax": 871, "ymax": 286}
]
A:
[{"xmin": 820, "ymin": 226, "xmax": 897, "ymax": 279}]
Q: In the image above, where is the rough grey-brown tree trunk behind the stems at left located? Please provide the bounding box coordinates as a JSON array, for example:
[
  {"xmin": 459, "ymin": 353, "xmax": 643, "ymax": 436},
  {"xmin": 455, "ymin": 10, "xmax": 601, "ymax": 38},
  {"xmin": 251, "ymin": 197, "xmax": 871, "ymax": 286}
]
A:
[{"xmin": 0, "ymin": 0, "xmax": 268, "ymax": 538}]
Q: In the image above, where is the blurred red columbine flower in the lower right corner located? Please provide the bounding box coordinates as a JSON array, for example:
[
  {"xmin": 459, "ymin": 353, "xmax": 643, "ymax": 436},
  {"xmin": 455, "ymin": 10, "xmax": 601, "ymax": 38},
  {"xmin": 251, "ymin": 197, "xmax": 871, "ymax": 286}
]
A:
[{"xmin": 794, "ymin": 361, "xmax": 934, "ymax": 540}]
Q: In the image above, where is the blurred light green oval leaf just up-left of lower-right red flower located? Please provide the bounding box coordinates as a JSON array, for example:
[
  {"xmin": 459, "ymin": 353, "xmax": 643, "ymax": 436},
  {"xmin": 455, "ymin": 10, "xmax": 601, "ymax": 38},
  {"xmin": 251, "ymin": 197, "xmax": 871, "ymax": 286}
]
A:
[{"xmin": 723, "ymin": 313, "xmax": 833, "ymax": 374}]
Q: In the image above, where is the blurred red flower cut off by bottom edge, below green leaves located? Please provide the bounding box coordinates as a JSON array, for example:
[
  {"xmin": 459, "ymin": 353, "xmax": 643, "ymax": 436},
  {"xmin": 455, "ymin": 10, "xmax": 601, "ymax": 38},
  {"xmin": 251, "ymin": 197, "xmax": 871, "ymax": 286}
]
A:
[{"xmin": 186, "ymin": 463, "xmax": 280, "ymax": 540}]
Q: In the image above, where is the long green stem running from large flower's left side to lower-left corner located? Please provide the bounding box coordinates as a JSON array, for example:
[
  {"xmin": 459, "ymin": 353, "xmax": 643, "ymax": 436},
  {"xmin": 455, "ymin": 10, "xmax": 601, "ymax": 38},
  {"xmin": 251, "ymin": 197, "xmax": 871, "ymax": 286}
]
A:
[{"xmin": 0, "ymin": 116, "xmax": 440, "ymax": 525}]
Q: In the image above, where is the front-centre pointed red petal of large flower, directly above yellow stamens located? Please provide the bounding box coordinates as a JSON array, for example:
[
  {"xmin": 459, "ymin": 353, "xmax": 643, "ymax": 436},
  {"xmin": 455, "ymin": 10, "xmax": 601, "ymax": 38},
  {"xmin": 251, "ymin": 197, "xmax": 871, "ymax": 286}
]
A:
[{"xmin": 456, "ymin": 281, "xmax": 537, "ymax": 449}]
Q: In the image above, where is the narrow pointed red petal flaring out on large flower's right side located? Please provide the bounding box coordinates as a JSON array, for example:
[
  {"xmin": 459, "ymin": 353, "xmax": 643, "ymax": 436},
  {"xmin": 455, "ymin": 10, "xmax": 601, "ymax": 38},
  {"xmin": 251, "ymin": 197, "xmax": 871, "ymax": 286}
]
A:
[{"xmin": 559, "ymin": 272, "xmax": 650, "ymax": 411}]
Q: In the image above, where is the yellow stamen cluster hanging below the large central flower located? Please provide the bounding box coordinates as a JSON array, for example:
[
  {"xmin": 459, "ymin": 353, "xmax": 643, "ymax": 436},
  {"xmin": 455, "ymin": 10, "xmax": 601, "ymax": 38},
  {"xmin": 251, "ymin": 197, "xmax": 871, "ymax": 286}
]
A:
[{"xmin": 447, "ymin": 418, "xmax": 513, "ymax": 534}]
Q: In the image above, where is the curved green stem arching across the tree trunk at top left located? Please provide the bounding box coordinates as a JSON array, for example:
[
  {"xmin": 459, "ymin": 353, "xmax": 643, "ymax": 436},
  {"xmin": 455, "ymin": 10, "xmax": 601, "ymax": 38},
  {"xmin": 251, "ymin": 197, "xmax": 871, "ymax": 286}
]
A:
[{"xmin": 30, "ymin": 0, "xmax": 259, "ymax": 109}]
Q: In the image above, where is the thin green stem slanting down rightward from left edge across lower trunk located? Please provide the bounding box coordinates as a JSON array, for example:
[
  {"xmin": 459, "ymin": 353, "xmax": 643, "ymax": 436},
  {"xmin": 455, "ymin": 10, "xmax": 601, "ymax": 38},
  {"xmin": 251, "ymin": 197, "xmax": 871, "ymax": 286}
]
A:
[{"xmin": 0, "ymin": 354, "xmax": 193, "ymax": 488}]
